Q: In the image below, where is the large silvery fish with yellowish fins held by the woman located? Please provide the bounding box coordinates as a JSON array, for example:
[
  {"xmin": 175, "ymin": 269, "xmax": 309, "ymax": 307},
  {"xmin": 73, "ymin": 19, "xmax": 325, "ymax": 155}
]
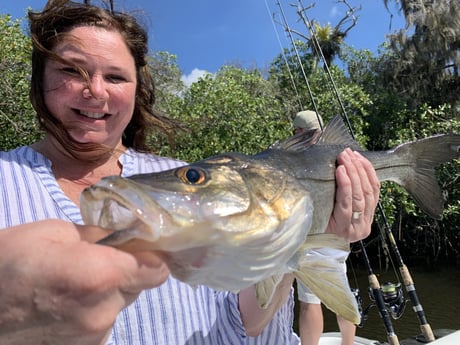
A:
[{"xmin": 80, "ymin": 116, "xmax": 460, "ymax": 324}]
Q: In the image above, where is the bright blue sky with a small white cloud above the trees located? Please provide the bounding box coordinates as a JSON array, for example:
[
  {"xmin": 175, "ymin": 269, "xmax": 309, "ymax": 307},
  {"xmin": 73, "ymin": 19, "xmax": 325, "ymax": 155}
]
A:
[{"xmin": 0, "ymin": 0, "xmax": 404, "ymax": 84}]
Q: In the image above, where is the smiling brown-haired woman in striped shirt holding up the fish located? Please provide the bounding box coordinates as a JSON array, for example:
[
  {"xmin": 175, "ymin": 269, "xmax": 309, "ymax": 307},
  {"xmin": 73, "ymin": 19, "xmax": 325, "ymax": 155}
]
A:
[{"xmin": 0, "ymin": 0, "xmax": 379, "ymax": 345}]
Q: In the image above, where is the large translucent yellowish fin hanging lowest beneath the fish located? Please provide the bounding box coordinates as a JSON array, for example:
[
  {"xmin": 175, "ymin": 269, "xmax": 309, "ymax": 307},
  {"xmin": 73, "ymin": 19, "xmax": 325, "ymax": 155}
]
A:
[{"xmin": 294, "ymin": 257, "xmax": 361, "ymax": 324}]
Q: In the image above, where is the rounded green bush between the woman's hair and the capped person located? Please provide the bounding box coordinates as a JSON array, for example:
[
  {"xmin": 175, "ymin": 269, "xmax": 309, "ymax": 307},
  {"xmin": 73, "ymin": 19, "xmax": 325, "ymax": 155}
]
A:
[{"xmin": 158, "ymin": 66, "xmax": 290, "ymax": 161}]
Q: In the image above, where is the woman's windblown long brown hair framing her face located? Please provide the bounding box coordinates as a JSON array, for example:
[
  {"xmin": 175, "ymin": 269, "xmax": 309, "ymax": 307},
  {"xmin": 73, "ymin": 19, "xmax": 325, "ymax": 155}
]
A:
[{"xmin": 29, "ymin": 0, "xmax": 171, "ymax": 152}]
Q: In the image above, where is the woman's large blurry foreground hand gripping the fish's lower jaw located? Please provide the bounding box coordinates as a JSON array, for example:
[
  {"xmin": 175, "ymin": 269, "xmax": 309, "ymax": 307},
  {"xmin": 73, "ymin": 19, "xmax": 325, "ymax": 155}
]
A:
[{"xmin": 0, "ymin": 220, "xmax": 169, "ymax": 345}]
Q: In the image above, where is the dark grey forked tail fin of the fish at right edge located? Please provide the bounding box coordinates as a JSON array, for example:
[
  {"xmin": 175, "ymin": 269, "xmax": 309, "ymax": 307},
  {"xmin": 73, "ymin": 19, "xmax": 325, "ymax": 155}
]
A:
[{"xmin": 377, "ymin": 134, "xmax": 460, "ymax": 219}]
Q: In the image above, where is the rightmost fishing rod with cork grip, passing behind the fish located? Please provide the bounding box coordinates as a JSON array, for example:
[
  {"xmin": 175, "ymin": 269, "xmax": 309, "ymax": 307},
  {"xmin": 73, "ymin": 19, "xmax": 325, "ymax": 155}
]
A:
[{"xmin": 292, "ymin": 0, "xmax": 435, "ymax": 341}]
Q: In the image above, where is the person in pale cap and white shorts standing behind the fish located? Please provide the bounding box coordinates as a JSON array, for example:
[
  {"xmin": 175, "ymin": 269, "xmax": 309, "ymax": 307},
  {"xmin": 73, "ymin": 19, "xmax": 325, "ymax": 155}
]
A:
[{"xmin": 293, "ymin": 110, "xmax": 356, "ymax": 345}]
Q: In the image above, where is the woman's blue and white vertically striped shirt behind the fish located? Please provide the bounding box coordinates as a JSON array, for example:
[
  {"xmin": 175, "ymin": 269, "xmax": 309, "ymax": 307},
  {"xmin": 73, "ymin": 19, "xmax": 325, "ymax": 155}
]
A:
[{"xmin": 0, "ymin": 147, "xmax": 299, "ymax": 345}]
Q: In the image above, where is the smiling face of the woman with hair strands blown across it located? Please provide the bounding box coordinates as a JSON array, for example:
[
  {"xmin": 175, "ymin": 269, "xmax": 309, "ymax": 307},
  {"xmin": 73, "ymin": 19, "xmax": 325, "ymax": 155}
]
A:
[{"xmin": 44, "ymin": 26, "xmax": 137, "ymax": 147}]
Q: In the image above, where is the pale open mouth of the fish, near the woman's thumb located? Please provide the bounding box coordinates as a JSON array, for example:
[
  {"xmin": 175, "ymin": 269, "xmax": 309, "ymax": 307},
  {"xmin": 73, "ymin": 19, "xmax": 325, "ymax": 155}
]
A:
[{"xmin": 80, "ymin": 176, "xmax": 172, "ymax": 241}]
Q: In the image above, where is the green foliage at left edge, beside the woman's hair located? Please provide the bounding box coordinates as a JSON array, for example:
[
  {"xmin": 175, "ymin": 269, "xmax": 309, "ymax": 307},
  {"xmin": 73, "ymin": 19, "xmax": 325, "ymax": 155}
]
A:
[{"xmin": 0, "ymin": 15, "xmax": 41, "ymax": 150}]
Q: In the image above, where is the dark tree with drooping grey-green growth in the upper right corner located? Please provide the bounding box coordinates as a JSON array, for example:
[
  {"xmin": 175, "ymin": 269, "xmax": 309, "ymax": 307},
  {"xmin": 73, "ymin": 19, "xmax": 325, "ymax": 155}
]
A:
[{"xmin": 382, "ymin": 0, "xmax": 460, "ymax": 109}]
